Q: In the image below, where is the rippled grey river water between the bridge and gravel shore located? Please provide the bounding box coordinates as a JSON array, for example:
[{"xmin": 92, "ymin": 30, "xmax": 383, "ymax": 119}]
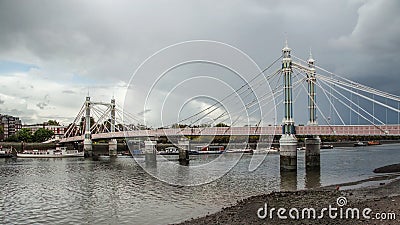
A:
[{"xmin": 0, "ymin": 144, "xmax": 400, "ymax": 224}]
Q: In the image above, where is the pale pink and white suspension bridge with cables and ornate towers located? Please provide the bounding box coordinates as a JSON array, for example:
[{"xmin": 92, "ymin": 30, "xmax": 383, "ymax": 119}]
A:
[{"xmin": 61, "ymin": 42, "xmax": 400, "ymax": 170}]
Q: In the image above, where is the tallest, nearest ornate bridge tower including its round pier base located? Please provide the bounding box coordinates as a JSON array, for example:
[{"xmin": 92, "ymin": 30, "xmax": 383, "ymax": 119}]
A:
[{"xmin": 279, "ymin": 41, "xmax": 297, "ymax": 171}]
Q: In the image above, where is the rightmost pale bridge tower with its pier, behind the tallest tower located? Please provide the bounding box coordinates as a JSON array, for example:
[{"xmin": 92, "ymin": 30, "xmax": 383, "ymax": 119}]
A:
[{"xmin": 305, "ymin": 51, "xmax": 321, "ymax": 169}]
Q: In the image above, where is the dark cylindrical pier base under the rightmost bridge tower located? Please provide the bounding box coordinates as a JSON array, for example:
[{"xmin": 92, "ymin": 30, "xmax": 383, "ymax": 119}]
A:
[{"xmin": 305, "ymin": 136, "xmax": 321, "ymax": 169}]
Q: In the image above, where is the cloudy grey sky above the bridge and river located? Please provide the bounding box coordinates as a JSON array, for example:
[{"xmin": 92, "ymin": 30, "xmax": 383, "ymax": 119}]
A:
[{"xmin": 0, "ymin": 0, "xmax": 400, "ymax": 126}]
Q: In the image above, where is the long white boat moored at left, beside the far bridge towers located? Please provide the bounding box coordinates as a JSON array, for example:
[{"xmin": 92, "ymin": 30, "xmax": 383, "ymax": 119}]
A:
[{"xmin": 17, "ymin": 147, "xmax": 84, "ymax": 158}]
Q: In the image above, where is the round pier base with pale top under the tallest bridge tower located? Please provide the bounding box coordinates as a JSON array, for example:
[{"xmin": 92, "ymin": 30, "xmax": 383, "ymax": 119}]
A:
[{"xmin": 279, "ymin": 134, "xmax": 297, "ymax": 171}]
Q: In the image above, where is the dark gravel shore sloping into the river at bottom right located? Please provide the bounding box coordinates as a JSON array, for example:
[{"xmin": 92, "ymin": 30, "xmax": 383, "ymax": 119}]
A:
[{"xmin": 175, "ymin": 175, "xmax": 400, "ymax": 225}]
